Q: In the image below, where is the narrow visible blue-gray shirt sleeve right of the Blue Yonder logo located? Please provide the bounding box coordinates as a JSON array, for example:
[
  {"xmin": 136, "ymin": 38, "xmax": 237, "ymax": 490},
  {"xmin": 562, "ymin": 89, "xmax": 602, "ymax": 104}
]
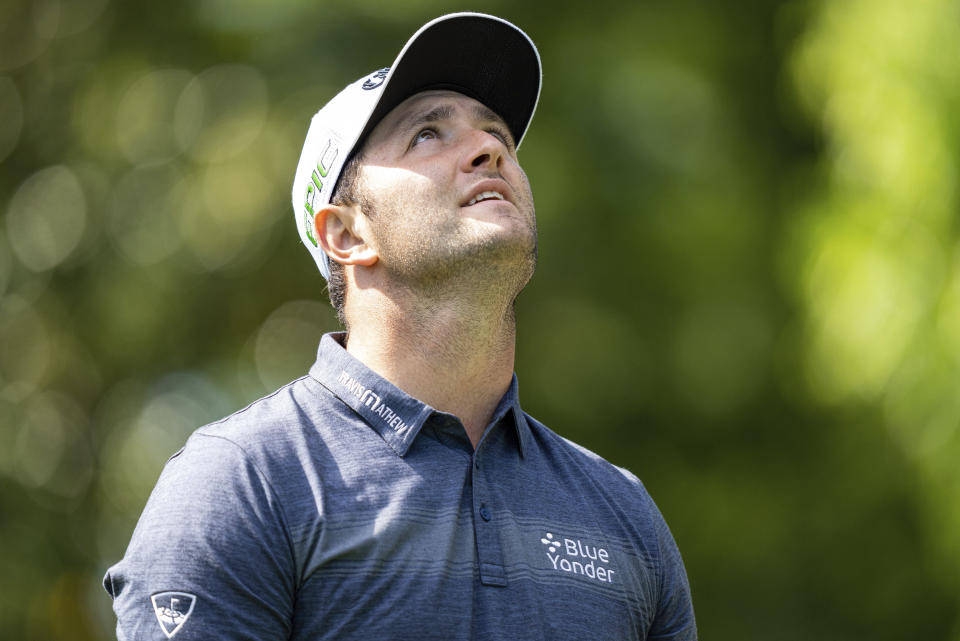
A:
[{"xmin": 647, "ymin": 506, "xmax": 697, "ymax": 641}]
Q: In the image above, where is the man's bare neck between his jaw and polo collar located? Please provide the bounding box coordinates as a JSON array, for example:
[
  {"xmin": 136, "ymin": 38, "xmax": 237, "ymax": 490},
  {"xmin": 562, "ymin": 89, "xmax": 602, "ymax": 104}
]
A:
[{"xmin": 346, "ymin": 292, "xmax": 516, "ymax": 447}]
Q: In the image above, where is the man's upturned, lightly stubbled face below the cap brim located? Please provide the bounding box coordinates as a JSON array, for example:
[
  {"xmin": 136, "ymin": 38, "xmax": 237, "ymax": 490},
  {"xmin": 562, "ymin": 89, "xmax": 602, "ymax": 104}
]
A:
[{"xmin": 352, "ymin": 91, "xmax": 536, "ymax": 291}]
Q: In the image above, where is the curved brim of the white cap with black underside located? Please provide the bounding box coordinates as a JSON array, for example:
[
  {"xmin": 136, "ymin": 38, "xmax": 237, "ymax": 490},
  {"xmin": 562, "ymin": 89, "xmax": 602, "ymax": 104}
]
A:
[{"xmin": 354, "ymin": 13, "xmax": 541, "ymax": 149}]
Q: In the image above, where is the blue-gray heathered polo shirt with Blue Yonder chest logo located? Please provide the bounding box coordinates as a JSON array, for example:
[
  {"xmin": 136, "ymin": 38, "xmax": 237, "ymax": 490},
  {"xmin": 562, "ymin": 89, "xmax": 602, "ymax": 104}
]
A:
[{"xmin": 104, "ymin": 334, "xmax": 696, "ymax": 641}]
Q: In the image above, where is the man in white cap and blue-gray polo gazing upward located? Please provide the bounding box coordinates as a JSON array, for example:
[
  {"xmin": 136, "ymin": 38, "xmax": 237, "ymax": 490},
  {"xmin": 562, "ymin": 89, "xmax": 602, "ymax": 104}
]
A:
[{"xmin": 104, "ymin": 14, "xmax": 696, "ymax": 641}]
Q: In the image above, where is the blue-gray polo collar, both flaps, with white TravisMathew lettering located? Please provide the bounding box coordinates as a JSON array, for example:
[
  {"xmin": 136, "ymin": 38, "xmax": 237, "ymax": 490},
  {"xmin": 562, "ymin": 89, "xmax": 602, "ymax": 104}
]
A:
[{"xmin": 310, "ymin": 332, "xmax": 530, "ymax": 456}]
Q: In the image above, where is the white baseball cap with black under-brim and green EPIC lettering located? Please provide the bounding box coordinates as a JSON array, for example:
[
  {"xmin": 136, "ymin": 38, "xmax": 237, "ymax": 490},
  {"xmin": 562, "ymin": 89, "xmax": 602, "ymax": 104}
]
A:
[{"xmin": 292, "ymin": 13, "xmax": 542, "ymax": 278}]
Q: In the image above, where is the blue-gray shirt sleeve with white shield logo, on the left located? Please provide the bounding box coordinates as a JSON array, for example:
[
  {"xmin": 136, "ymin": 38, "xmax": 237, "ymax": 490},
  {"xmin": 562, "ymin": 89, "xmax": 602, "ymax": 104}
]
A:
[{"xmin": 103, "ymin": 433, "xmax": 296, "ymax": 641}]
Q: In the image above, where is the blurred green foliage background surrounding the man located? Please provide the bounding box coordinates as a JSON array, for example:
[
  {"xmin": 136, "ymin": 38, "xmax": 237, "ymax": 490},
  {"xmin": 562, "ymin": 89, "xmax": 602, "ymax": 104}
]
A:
[{"xmin": 0, "ymin": 0, "xmax": 960, "ymax": 641}]
